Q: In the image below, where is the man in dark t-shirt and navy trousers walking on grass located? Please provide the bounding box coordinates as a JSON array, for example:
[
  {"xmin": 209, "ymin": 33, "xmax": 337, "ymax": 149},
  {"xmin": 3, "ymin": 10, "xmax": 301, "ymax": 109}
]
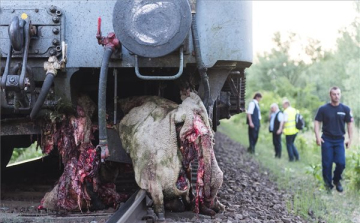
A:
[{"xmin": 314, "ymin": 87, "xmax": 353, "ymax": 192}]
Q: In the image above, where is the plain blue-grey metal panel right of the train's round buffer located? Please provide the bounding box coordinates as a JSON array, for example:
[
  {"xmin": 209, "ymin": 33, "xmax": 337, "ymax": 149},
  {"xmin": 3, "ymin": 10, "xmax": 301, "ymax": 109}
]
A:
[{"xmin": 196, "ymin": 0, "xmax": 253, "ymax": 67}]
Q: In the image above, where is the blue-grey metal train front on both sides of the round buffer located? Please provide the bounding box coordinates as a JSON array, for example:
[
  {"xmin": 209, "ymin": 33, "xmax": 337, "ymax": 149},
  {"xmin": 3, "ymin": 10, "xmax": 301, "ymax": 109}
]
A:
[{"xmin": 0, "ymin": 0, "xmax": 252, "ymax": 68}]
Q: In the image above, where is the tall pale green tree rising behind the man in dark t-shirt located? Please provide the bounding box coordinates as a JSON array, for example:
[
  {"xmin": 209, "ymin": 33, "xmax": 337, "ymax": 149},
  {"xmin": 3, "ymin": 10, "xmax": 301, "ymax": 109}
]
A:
[{"xmin": 307, "ymin": 1, "xmax": 360, "ymax": 125}]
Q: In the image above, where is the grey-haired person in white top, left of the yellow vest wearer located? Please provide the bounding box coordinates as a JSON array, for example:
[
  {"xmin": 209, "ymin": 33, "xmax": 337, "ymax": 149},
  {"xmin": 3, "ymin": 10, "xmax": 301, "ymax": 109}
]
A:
[{"xmin": 269, "ymin": 103, "xmax": 284, "ymax": 159}]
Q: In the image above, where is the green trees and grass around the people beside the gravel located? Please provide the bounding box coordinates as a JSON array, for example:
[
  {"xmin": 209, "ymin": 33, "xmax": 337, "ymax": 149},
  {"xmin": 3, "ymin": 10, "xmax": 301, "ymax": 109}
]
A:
[{"xmin": 219, "ymin": 1, "xmax": 360, "ymax": 223}]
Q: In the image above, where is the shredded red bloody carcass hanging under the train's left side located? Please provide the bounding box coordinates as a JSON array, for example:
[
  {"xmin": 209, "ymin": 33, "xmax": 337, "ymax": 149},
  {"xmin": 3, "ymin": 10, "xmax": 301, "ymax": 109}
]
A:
[{"xmin": 39, "ymin": 96, "xmax": 127, "ymax": 211}]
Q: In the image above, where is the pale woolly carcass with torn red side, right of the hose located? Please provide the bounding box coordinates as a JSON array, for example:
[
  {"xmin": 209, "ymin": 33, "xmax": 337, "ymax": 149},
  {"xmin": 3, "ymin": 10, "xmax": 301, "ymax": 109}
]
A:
[{"xmin": 118, "ymin": 92, "xmax": 223, "ymax": 218}]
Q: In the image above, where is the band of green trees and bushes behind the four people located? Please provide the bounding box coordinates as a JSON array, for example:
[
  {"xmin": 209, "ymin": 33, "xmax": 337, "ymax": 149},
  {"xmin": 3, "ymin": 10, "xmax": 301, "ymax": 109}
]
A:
[{"xmin": 247, "ymin": 1, "xmax": 360, "ymax": 128}]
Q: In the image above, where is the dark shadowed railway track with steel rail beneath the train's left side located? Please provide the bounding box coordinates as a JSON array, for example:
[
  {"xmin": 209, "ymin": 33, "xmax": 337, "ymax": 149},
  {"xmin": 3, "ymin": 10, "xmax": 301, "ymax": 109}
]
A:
[{"xmin": 0, "ymin": 153, "xmax": 180, "ymax": 223}]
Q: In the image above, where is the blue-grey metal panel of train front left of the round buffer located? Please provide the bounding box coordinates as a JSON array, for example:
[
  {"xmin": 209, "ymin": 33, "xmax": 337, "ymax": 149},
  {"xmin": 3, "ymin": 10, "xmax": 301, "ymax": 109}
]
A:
[{"xmin": 0, "ymin": 0, "xmax": 115, "ymax": 68}]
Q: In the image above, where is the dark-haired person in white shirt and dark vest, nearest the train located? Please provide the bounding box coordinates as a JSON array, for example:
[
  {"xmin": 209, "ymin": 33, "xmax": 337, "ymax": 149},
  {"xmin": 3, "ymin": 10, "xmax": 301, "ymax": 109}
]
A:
[{"xmin": 246, "ymin": 93, "xmax": 262, "ymax": 153}]
